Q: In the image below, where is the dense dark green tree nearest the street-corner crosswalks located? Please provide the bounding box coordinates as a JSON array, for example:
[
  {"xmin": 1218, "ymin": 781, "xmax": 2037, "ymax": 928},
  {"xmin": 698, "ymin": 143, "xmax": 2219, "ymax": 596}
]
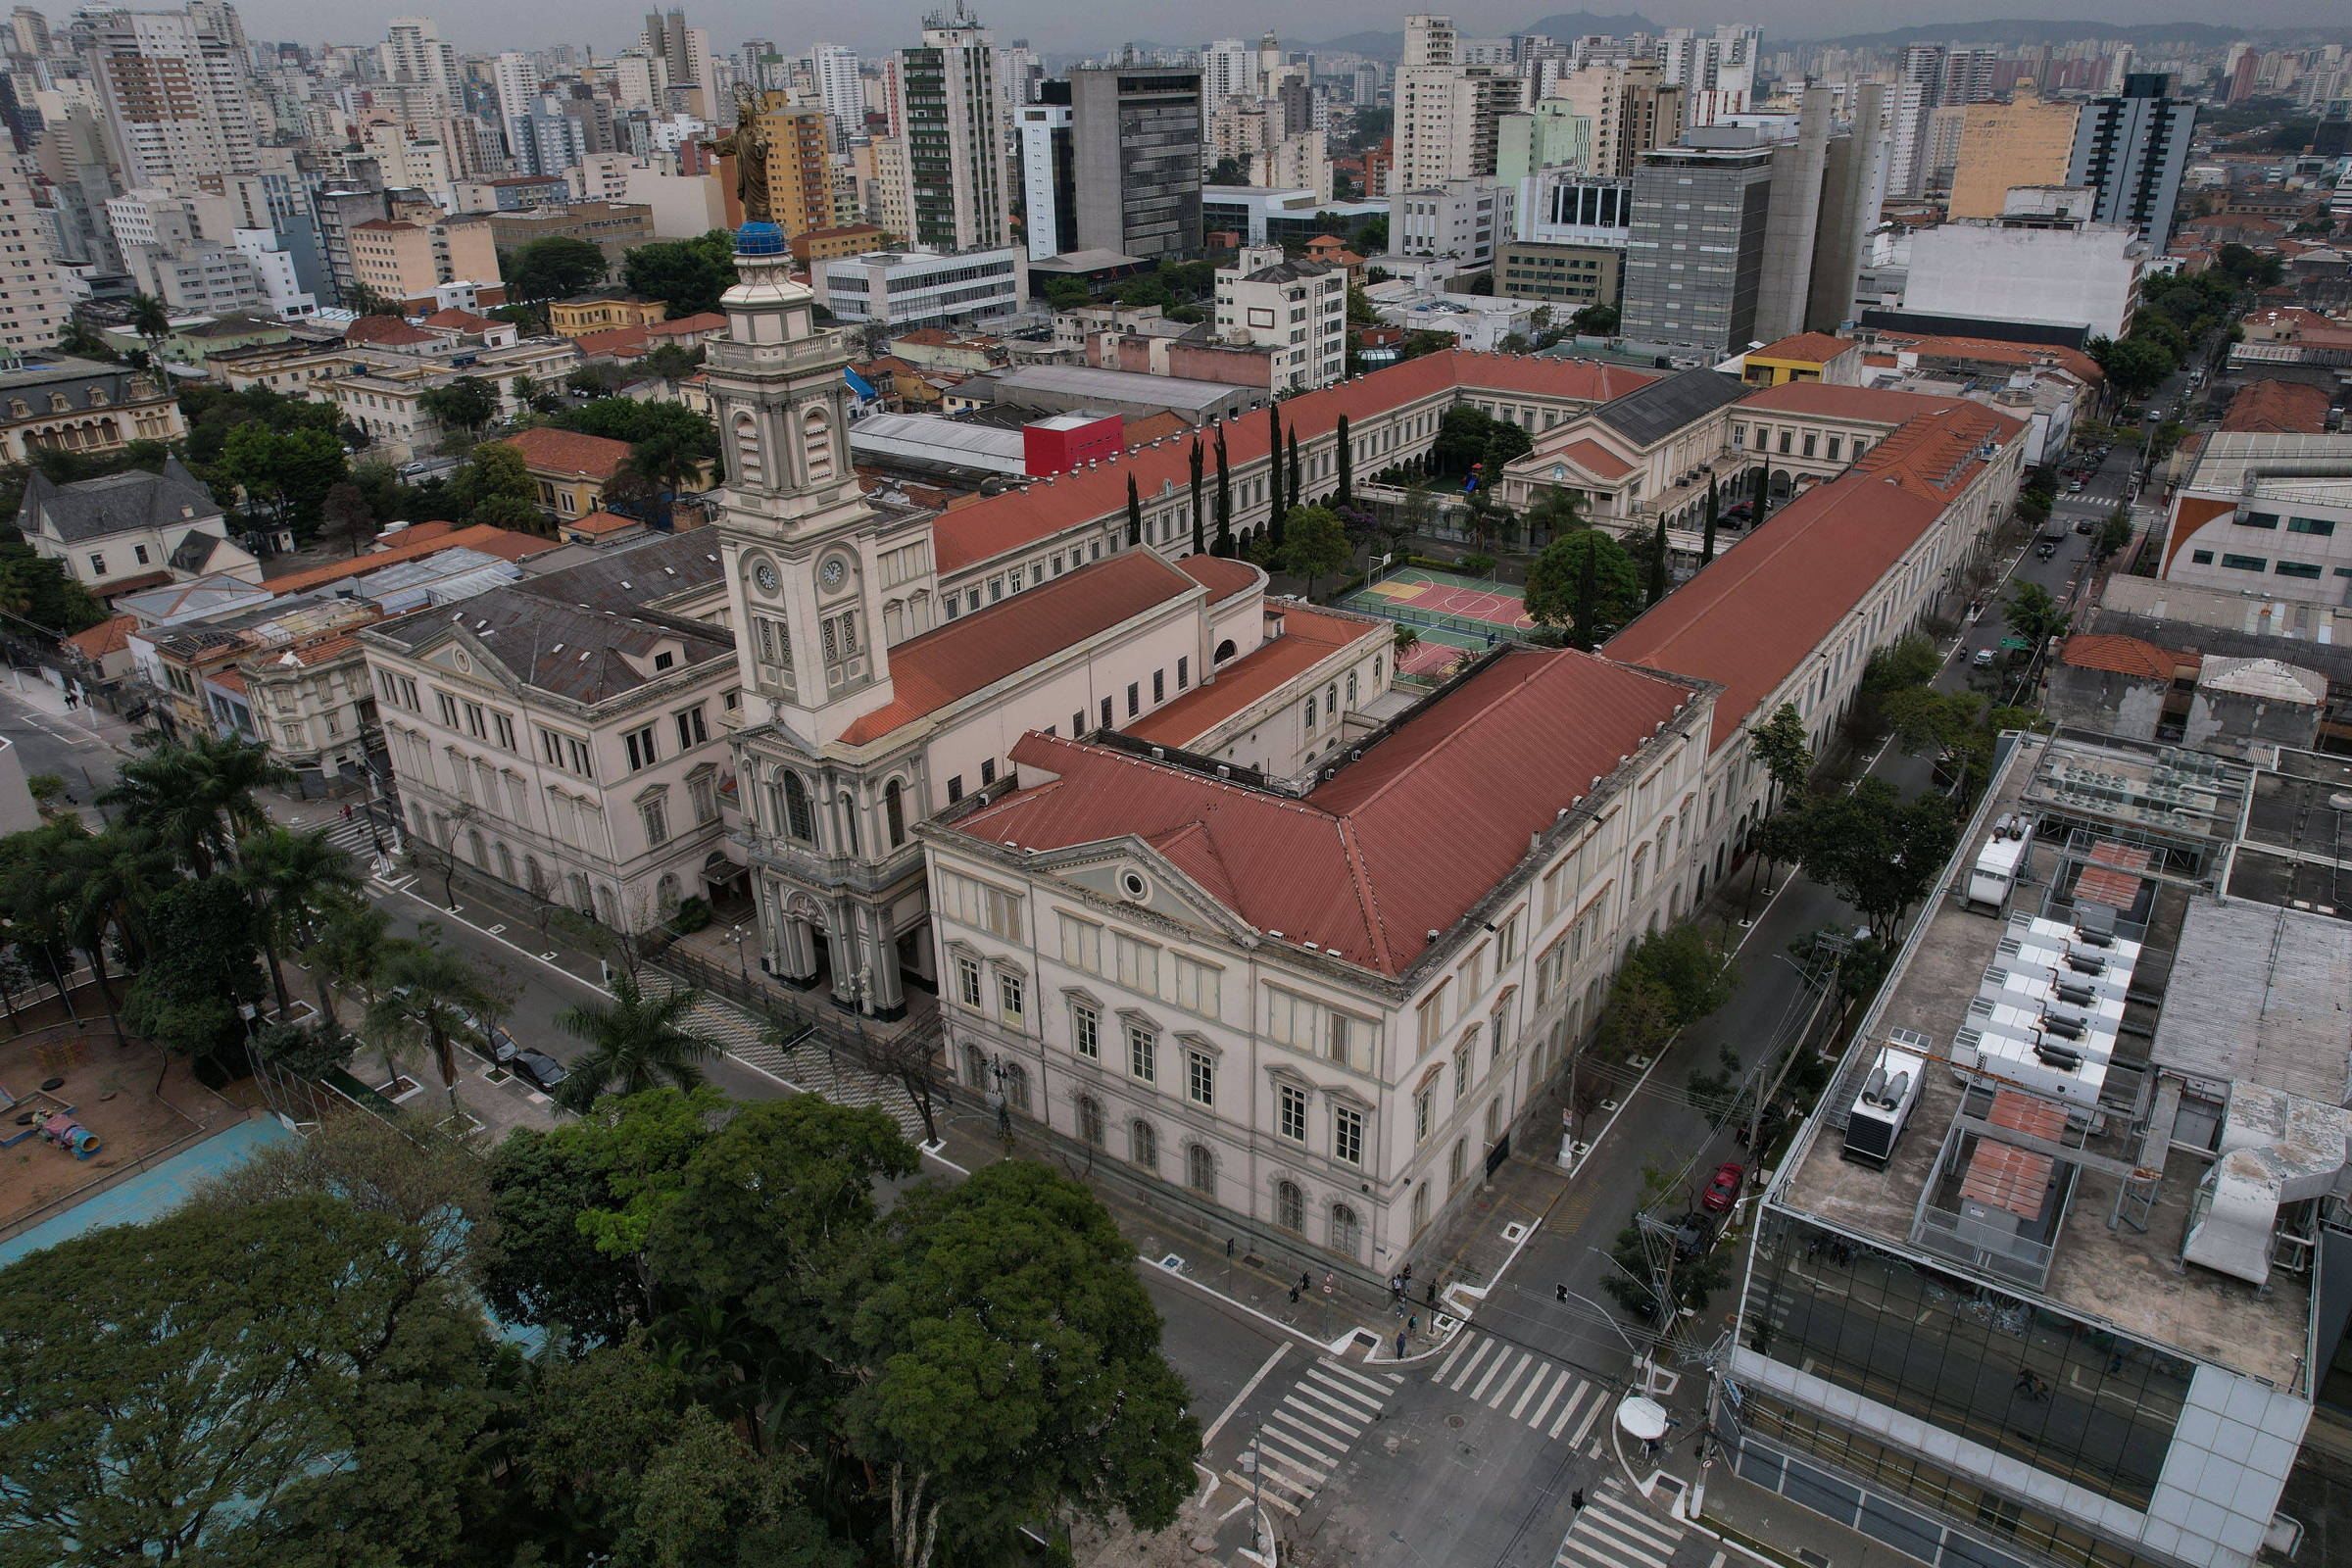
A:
[{"xmin": 842, "ymin": 1161, "xmax": 1200, "ymax": 1568}]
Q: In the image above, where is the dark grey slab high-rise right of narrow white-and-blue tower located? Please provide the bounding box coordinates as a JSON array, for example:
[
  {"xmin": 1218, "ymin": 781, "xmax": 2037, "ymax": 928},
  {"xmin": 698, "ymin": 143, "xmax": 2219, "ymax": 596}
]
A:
[{"xmin": 1070, "ymin": 66, "xmax": 1201, "ymax": 261}]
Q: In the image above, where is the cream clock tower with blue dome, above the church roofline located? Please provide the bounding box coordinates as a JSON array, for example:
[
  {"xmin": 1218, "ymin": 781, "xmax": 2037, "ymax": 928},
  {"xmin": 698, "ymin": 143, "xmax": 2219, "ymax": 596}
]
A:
[{"xmin": 704, "ymin": 223, "xmax": 892, "ymax": 745}]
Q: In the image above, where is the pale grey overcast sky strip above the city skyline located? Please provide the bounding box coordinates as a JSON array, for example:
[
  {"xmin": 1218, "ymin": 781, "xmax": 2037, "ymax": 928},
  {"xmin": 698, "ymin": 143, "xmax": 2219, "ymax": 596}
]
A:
[{"xmin": 237, "ymin": 0, "xmax": 2352, "ymax": 54}]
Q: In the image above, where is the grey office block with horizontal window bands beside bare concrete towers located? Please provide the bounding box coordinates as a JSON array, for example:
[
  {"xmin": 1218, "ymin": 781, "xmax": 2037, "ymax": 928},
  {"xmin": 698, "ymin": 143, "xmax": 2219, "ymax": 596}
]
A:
[{"xmin": 1621, "ymin": 129, "xmax": 1774, "ymax": 353}]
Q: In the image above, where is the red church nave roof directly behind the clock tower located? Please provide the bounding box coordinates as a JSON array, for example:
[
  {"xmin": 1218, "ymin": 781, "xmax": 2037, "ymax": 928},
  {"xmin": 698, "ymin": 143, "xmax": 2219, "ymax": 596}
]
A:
[{"xmin": 842, "ymin": 550, "xmax": 1193, "ymax": 745}]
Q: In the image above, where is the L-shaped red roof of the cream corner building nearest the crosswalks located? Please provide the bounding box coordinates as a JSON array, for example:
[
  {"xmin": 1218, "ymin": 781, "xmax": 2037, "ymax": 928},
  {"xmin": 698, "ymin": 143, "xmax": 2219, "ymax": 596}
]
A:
[{"xmin": 959, "ymin": 649, "xmax": 1691, "ymax": 976}]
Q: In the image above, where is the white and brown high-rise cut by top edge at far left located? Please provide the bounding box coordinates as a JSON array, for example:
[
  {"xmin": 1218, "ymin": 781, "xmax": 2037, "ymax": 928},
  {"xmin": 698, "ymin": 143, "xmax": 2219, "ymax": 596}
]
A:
[{"xmin": 87, "ymin": 5, "xmax": 257, "ymax": 186}]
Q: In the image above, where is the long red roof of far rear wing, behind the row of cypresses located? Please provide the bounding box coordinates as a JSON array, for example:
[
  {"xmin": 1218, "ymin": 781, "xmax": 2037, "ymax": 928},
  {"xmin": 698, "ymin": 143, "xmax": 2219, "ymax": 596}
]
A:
[{"xmin": 934, "ymin": 350, "xmax": 1656, "ymax": 576}]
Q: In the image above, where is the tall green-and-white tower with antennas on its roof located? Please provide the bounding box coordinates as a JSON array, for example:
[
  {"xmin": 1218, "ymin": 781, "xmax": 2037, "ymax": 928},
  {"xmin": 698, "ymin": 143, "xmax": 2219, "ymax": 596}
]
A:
[{"xmin": 899, "ymin": 0, "xmax": 1011, "ymax": 252}]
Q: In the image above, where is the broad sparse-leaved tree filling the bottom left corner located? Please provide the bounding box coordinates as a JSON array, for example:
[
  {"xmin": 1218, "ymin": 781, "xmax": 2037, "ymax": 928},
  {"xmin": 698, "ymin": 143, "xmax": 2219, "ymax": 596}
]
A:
[{"xmin": 0, "ymin": 1197, "xmax": 489, "ymax": 1566}]
